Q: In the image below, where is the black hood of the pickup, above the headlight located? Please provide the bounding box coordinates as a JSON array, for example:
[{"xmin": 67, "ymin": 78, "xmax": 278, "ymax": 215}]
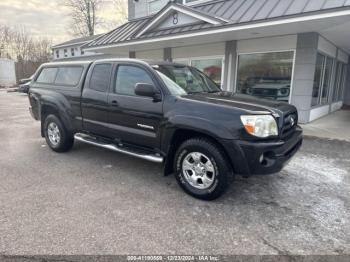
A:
[{"xmin": 182, "ymin": 92, "xmax": 296, "ymax": 116}]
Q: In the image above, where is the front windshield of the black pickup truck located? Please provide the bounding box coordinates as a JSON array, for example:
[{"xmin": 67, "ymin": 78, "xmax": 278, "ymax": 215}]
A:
[{"xmin": 155, "ymin": 65, "xmax": 221, "ymax": 94}]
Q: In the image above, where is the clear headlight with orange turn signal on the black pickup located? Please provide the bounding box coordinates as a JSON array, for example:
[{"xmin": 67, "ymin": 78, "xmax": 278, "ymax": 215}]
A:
[{"xmin": 241, "ymin": 115, "xmax": 278, "ymax": 137}]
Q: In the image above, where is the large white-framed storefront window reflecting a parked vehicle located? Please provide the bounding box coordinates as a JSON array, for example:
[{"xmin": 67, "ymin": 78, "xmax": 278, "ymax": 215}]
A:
[{"xmin": 236, "ymin": 51, "xmax": 294, "ymax": 102}]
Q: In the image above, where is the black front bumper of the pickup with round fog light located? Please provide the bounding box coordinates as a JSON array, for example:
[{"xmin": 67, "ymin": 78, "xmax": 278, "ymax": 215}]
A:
[{"xmin": 225, "ymin": 127, "xmax": 303, "ymax": 176}]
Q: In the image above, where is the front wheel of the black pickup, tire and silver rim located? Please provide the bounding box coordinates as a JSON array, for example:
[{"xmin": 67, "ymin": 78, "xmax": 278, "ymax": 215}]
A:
[{"xmin": 175, "ymin": 138, "xmax": 232, "ymax": 200}]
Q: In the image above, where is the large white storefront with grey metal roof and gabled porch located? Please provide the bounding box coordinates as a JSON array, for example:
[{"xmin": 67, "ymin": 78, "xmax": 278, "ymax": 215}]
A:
[{"xmin": 84, "ymin": 0, "xmax": 350, "ymax": 123}]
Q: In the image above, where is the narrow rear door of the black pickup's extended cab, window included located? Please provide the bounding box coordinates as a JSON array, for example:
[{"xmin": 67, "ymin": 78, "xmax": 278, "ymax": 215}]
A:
[{"xmin": 81, "ymin": 62, "xmax": 113, "ymax": 137}]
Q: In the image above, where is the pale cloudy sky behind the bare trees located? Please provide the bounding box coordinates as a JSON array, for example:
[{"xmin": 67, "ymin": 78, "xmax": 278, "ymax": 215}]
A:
[{"xmin": 0, "ymin": 0, "xmax": 126, "ymax": 44}]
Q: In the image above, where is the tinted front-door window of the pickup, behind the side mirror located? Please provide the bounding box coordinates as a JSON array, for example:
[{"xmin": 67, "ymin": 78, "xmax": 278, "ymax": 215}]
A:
[{"xmin": 115, "ymin": 66, "xmax": 153, "ymax": 96}]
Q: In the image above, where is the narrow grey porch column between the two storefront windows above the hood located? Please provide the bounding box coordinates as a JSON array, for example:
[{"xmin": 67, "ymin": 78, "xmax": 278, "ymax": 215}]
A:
[{"xmin": 223, "ymin": 41, "xmax": 237, "ymax": 91}]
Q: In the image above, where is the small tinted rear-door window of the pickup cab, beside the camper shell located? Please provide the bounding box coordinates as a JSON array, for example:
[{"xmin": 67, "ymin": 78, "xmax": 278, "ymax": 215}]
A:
[{"xmin": 90, "ymin": 64, "xmax": 112, "ymax": 92}]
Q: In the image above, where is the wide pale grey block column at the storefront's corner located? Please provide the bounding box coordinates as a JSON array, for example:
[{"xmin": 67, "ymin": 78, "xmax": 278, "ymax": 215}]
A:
[{"xmin": 292, "ymin": 33, "xmax": 318, "ymax": 123}]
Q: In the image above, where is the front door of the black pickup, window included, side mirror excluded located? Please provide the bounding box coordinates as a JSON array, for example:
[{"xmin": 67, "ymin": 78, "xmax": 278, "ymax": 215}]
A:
[{"xmin": 108, "ymin": 63, "xmax": 163, "ymax": 150}]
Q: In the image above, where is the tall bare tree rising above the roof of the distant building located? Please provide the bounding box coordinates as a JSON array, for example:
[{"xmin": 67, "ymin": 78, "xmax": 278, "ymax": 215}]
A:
[{"xmin": 65, "ymin": 0, "xmax": 103, "ymax": 36}]
